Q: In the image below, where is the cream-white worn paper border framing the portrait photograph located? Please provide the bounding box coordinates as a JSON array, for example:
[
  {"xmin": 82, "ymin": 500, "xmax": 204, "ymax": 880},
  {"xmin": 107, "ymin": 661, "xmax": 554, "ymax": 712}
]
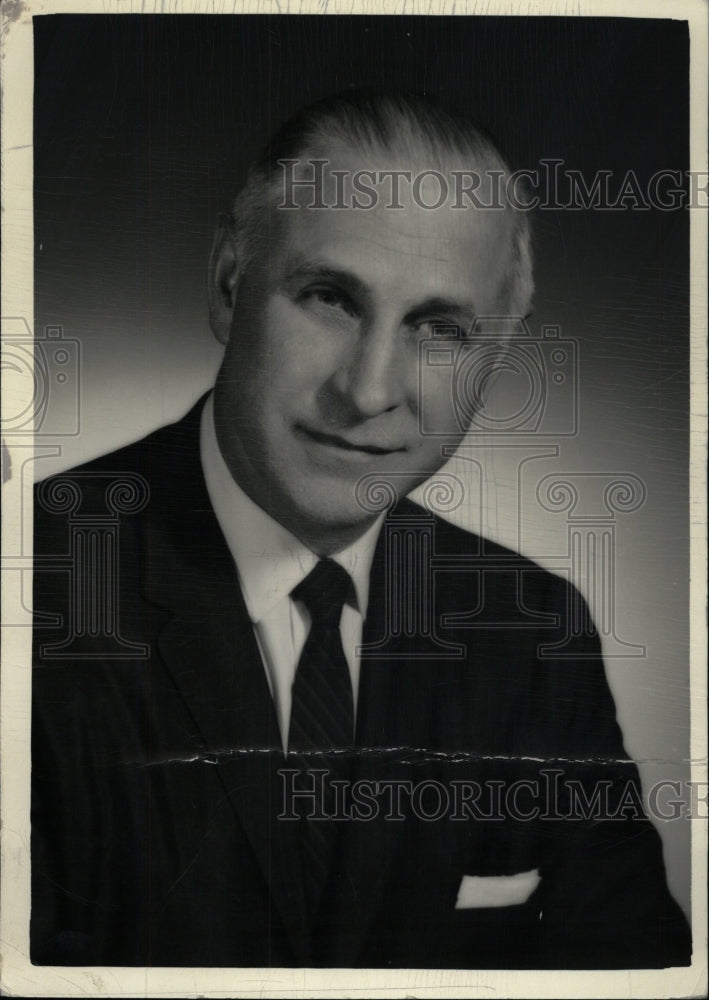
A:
[{"xmin": 0, "ymin": 0, "xmax": 709, "ymax": 998}]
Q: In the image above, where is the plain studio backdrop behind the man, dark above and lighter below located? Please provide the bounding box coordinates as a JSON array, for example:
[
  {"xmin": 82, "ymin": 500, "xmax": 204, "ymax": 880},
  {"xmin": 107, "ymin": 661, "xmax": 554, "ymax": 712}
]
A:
[{"xmin": 34, "ymin": 6, "xmax": 689, "ymax": 907}]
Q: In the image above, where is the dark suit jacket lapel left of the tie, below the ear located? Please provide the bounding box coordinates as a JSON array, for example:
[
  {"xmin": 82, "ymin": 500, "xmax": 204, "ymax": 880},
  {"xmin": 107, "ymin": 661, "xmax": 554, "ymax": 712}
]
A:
[{"xmin": 144, "ymin": 402, "xmax": 308, "ymax": 965}]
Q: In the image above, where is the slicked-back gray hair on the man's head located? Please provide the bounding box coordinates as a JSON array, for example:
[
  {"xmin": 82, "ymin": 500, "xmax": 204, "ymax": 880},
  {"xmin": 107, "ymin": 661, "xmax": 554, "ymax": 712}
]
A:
[{"xmin": 227, "ymin": 91, "xmax": 534, "ymax": 316}]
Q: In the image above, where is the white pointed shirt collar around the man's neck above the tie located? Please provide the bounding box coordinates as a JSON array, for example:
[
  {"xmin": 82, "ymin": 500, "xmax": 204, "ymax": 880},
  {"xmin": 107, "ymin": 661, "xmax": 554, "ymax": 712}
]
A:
[{"xmin": 200, "ymin": 395, "xmax": 384, "ymax": 623}]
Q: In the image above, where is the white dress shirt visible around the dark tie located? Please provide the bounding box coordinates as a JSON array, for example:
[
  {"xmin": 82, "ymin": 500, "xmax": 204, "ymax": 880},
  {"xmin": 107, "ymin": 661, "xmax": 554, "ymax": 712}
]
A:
[{"xmin": 200, "ymin": 395, "xmax": 383, "ymax": 751}]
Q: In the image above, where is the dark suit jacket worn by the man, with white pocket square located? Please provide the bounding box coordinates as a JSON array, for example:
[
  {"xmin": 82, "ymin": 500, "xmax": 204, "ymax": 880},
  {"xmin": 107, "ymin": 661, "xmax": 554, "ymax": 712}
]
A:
[{"xmin": 31, "ymin": 398, "xmax": 690, "ymax": 968}]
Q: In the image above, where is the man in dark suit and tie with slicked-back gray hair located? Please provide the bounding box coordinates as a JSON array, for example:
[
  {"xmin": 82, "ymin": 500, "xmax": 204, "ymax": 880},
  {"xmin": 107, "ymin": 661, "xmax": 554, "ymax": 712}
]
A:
[{"xmin": 31, "ymin": 94, "xmax": 690, "ymax": 968}]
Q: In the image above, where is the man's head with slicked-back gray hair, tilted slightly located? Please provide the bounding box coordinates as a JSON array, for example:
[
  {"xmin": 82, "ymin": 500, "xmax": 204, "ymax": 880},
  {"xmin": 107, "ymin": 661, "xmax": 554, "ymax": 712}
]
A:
[{"xmin": 210, "ymin": 95, "xmax": 532, "ymax": 554}]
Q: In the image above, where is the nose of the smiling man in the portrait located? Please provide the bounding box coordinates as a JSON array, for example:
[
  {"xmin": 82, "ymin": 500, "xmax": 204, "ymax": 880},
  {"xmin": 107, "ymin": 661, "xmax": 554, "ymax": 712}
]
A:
[{"xmin": 333, "ymin": 325, "xmax": 406, "ymax": 418}]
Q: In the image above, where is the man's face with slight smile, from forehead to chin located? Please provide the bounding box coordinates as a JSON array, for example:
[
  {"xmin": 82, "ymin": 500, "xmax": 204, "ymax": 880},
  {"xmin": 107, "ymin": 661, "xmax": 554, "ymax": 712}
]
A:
[{"xmin": 215, "ymin": 158, "xmax": 512, "ymax": 553}]
